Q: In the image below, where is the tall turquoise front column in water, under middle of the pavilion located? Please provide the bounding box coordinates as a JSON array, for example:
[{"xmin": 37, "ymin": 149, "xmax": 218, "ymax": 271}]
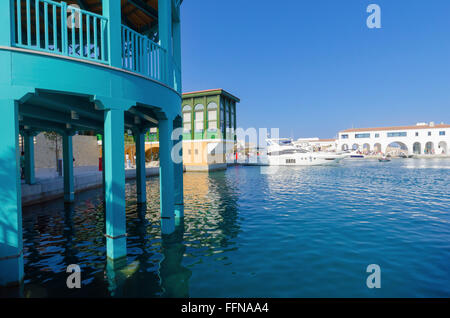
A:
[{"xmin": 103, "ymin": 109, "xmax": 127, "ymax": 259}]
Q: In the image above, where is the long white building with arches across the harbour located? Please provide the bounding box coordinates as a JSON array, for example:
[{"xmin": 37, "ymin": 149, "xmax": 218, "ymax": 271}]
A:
[{"xmin": 337, "ymin": 122, "xmax": 450, "ymax": 155}]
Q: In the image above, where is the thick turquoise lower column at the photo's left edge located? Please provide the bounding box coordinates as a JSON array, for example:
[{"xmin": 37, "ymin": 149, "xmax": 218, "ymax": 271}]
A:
[{"xmin": 0, "ymin": 99, "xmax": 24, "ymax": 286}]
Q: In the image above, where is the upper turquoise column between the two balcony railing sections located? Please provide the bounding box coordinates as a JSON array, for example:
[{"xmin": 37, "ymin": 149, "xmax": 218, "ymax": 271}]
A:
[{"xmin": 102, "ymin": 0, "xmax": 122, "ymax": 67}]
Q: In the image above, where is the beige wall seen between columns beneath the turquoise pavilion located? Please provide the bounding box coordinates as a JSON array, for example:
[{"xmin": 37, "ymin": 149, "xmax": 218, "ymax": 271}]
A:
[{"xmin": 34, "ymin": 133, "xmax": 101, "ymax": 169}]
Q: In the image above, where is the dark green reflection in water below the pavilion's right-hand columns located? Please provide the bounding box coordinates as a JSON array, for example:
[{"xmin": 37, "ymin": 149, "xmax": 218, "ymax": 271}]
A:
[{"xmin": 159, "ymin": 219, "xmax": 192, "ymax": 298}]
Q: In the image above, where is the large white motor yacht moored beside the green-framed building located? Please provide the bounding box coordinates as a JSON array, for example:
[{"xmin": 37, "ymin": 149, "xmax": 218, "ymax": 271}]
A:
[{"xmin": 267, "ymin": 138, "xmax": 348, "ymax": 166}]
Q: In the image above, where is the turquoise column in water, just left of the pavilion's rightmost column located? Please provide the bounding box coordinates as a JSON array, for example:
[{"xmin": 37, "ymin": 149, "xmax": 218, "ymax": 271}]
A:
[{"xmin": 159, "ymin": 119, "xmax": 175, "ymax": 234}]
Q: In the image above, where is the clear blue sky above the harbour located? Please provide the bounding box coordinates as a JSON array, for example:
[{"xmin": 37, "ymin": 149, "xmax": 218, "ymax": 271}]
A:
[{"xmin": 182, "ymin": 0, "xmax": 450, "ymax": 138}]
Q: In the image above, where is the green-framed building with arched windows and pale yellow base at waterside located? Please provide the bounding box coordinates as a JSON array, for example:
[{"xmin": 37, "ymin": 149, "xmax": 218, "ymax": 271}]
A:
[{"xmin": 181, "ymin": 89, "xmax": 240, "ymax": 171}]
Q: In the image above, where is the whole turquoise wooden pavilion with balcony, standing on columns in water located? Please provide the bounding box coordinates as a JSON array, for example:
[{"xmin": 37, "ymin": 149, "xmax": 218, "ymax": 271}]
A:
[{"xmin": 0, "ymin": 0, "xmax": 183, "ymax": 286}]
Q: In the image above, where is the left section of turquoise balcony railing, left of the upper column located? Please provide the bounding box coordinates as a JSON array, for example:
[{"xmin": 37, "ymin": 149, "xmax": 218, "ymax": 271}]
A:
[{"xmin": 15, "ymin": 0, "xmax": 109, "ymax": 64}]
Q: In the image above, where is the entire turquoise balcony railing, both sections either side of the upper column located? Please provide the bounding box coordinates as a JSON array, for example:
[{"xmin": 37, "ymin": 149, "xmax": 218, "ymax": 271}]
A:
[{"xmin": 11, "ymin": 0, "xmax": 181, "ymax": 92}]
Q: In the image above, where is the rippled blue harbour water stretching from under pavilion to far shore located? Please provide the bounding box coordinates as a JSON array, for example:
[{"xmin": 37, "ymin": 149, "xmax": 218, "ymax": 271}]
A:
[{"xmin": 16, "ymin": 159, "xmax": 450, "ymax": 297}]
